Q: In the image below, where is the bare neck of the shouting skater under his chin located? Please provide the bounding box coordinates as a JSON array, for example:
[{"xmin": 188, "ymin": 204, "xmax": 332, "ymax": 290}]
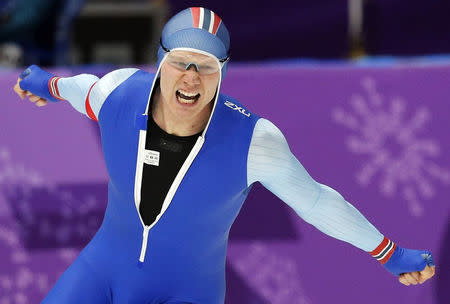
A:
[{"xmin": 151, "ymin": 88, "xmax": 213, "ymax": 136}]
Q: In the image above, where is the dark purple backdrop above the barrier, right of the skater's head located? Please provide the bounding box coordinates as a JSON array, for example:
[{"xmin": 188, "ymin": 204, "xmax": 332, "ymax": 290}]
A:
[{"xmin": 168, "ymin": 0, "xmax": 450, "ymax": 61}]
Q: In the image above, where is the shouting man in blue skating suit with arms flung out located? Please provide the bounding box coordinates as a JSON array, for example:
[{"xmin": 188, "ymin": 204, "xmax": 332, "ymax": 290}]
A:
[{"xmin": 15, "ymin": 7, "xmax": 434, "ymax": 304}]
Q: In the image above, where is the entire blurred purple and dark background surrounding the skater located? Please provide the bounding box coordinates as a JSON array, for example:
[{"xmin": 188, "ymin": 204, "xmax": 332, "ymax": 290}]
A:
[{"xmin": 0, "ymin": 0, "xmax": 450, "ymax": 304}]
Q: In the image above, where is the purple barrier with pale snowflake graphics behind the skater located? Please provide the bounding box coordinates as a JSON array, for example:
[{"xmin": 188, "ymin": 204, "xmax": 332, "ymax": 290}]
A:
[{"xmin": 0, "ymin": 64, "xmax": 450, "ymax": 304}]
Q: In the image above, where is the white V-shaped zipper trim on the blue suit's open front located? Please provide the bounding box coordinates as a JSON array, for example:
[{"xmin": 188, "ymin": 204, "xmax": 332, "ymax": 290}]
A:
[{"xmin": 134, "ymin": 130, "xmax": 205, "ymax": 263}]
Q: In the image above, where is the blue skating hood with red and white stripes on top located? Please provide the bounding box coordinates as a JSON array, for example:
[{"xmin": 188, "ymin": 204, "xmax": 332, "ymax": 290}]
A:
[{"xmin": 157, "ymin": 7, "xmax": 230, "ymax": 79}]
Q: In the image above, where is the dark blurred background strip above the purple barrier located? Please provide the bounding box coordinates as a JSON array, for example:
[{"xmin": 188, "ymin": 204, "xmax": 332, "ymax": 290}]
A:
[{"xmin": 0, "ymin": 0, "xmax": 450, "ymax": 65}]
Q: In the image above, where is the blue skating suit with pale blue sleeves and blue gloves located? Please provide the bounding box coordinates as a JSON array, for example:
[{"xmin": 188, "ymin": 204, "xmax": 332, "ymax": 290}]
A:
[{"xmin": 16, "ymin": 68, "xmax": 432, "ymax": 304}]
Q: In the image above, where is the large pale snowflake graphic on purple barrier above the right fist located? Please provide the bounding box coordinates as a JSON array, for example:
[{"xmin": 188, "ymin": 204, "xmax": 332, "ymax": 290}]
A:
[{"xmin": 332, "ymin": 77, "xmax": 450, "ymax": 217}]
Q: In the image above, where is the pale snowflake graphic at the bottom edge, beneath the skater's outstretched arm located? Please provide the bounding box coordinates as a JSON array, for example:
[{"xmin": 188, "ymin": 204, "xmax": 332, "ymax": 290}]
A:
[{"xmin": 232, "ymin": 242, "xmax": 311, "ymax": 304}]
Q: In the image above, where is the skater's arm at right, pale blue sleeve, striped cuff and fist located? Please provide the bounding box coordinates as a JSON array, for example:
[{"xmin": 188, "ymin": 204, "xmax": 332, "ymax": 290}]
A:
[{"xmin": 247, "ymin": 119, "xmax": 434, "ymax": 285}]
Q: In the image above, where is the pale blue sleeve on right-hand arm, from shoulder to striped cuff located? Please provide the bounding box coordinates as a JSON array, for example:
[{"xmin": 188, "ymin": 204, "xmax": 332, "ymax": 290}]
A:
[{"xmin": 247, "ymin": 118, "xmax": 384, "ymax": 252}]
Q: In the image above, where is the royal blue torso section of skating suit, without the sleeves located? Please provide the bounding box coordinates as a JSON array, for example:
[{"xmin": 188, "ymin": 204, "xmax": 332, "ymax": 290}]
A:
[{"xmin": 43, "ymin": 71, "xmax": 258, "ymax": 304}]
